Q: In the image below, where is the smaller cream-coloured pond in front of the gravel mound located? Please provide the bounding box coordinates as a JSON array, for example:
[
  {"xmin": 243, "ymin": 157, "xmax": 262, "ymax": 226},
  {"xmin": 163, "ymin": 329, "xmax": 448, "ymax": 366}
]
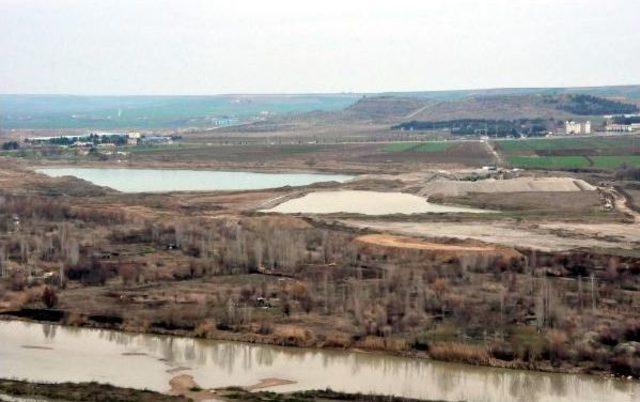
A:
[{"xmin": 263, "ymin": 190, "xmax": 492, "ymax": 215}]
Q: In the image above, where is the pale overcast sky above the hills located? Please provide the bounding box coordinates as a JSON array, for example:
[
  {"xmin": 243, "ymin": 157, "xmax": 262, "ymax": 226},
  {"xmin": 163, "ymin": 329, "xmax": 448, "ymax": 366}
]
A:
[{"xmin": 0, "ymin": 0, "xmax": 640, "ymax": 94}]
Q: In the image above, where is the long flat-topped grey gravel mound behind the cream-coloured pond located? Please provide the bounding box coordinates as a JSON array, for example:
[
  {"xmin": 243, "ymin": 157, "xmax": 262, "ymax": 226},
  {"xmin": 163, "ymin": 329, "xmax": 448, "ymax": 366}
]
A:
[{"xmin": 421, "ymin": 177, "xmax": 595, "ymax": 197}]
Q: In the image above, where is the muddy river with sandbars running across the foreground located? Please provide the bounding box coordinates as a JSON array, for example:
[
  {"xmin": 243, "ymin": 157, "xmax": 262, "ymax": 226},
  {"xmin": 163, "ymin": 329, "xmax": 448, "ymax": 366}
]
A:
[{"xmin": 0, "ymin": 321, "xmax": 640, "ymax": 402}]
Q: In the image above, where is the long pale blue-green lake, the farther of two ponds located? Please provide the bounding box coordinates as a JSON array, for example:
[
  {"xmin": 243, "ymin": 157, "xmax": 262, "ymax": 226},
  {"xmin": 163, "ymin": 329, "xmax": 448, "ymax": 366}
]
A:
[{"xmin": 36, "ymin": 167, "xmax": 353, "ymax": 193}]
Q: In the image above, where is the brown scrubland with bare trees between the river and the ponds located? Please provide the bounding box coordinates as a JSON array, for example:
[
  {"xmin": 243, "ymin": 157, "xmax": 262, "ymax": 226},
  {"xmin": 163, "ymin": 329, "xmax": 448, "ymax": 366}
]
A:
[{"xmin": 0, "ymin": 155, "xmax": 640, "ymax": 376}]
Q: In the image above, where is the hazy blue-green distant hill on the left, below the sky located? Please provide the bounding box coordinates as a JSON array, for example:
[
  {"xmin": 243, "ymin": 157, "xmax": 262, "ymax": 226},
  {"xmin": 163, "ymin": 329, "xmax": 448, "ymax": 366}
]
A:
[{"xmin": 0, "ymin": 94, "xmax": 359, "ymax": 129}]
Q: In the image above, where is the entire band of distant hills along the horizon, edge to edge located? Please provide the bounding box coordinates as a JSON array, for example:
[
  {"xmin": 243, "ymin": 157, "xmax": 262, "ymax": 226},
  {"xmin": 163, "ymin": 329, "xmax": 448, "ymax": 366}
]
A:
[{"xmin": 0, "ymin": 85, "xmax": 640, "ymax": 129}]
